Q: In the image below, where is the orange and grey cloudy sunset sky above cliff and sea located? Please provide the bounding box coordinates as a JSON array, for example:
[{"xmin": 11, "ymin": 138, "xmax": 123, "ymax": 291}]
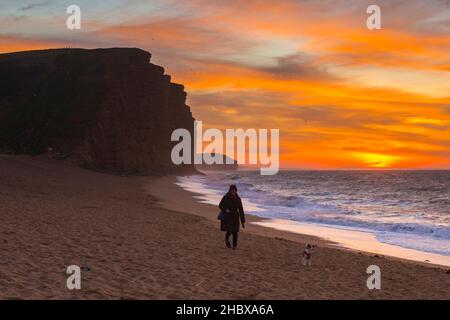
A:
[{"xmin": 0, "ymin": 0, "xmax": 450, "ymax": 169}]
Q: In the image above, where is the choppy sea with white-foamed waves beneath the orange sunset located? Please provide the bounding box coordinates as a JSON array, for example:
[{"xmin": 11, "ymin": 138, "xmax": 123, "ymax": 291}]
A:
[{"xmin": 177, "ymin": 170, "xmax": 450, "ymax": 256}]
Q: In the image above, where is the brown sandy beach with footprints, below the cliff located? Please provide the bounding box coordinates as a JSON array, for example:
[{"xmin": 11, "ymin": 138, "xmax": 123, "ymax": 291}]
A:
[{"xmin": 0, "ymin": 155, "xmax": 450, "ymax": 299}]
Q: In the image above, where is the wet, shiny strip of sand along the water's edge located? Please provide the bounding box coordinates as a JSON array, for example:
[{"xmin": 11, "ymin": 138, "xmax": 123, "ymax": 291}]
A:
[{"xmin": 149, "ymin": 176, "xmax": 450, "ymax": 270}]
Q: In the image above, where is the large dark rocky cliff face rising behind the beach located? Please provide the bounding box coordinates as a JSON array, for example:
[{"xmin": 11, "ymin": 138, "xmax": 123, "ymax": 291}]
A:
[{"xmin": 0, "ymin": 48, "xmax": 195, "ymax": 174}]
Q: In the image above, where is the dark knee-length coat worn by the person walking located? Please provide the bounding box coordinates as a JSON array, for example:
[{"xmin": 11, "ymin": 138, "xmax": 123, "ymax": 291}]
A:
[{"xmin": 219, "ymin": 193, "xmax": 245, "ymax": 232}]
